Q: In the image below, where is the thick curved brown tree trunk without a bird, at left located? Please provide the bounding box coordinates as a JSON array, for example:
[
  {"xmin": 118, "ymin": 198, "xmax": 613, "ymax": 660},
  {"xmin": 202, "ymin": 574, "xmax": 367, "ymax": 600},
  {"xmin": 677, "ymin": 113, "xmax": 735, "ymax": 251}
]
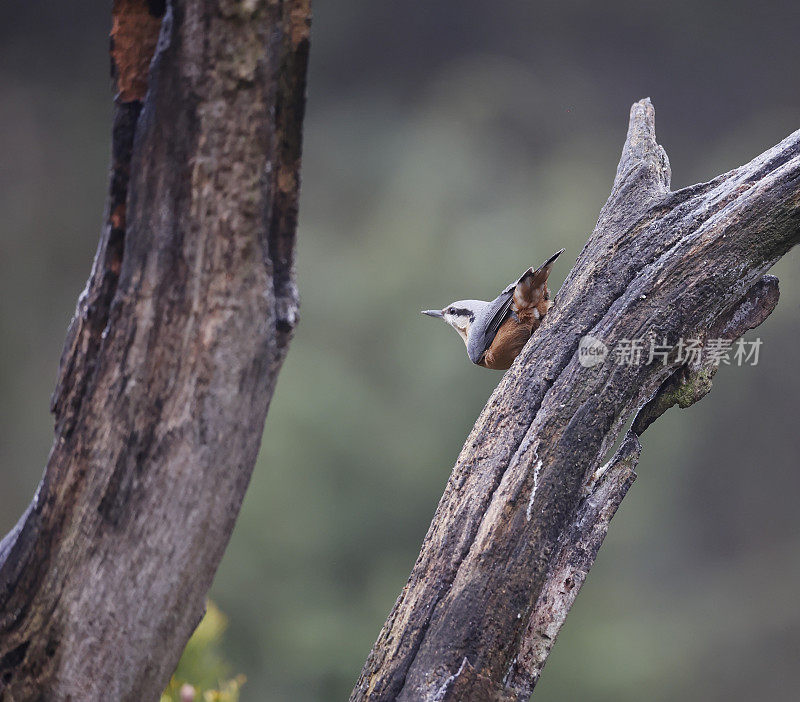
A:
[{"xmin": 0, "ymin": 0, "xmax": 310, "ymax": 700}]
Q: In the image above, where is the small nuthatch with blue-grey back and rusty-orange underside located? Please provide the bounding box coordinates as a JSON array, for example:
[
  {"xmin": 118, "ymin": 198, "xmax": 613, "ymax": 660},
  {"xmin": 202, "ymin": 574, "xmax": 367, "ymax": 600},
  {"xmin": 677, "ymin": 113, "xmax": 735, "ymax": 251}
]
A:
[{"xmin": 422, "ymin": 249, "xmax": 564, "ymax": 370}]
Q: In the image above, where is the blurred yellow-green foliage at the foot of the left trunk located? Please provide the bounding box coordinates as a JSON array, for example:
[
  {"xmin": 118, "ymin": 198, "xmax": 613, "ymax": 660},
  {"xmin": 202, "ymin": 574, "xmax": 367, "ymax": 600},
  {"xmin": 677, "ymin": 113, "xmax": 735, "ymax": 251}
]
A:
[{"xmin": 161, "ymin": 600, "xmax": 241, "ymax": 702}]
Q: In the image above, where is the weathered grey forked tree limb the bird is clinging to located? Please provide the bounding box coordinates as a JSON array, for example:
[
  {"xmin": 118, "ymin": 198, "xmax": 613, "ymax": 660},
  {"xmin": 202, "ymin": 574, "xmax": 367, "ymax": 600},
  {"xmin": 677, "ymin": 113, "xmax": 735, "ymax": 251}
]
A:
[{"xmin": 351, "ymin": 100, "xmax": 800, "ymax": 700}]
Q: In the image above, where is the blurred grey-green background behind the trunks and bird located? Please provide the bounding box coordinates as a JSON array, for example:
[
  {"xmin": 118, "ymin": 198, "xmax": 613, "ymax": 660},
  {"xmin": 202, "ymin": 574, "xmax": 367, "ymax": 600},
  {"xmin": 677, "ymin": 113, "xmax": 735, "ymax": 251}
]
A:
[{"xmin": 0, "ymin": 0, "xmax": 800, "ymax": 702}]
